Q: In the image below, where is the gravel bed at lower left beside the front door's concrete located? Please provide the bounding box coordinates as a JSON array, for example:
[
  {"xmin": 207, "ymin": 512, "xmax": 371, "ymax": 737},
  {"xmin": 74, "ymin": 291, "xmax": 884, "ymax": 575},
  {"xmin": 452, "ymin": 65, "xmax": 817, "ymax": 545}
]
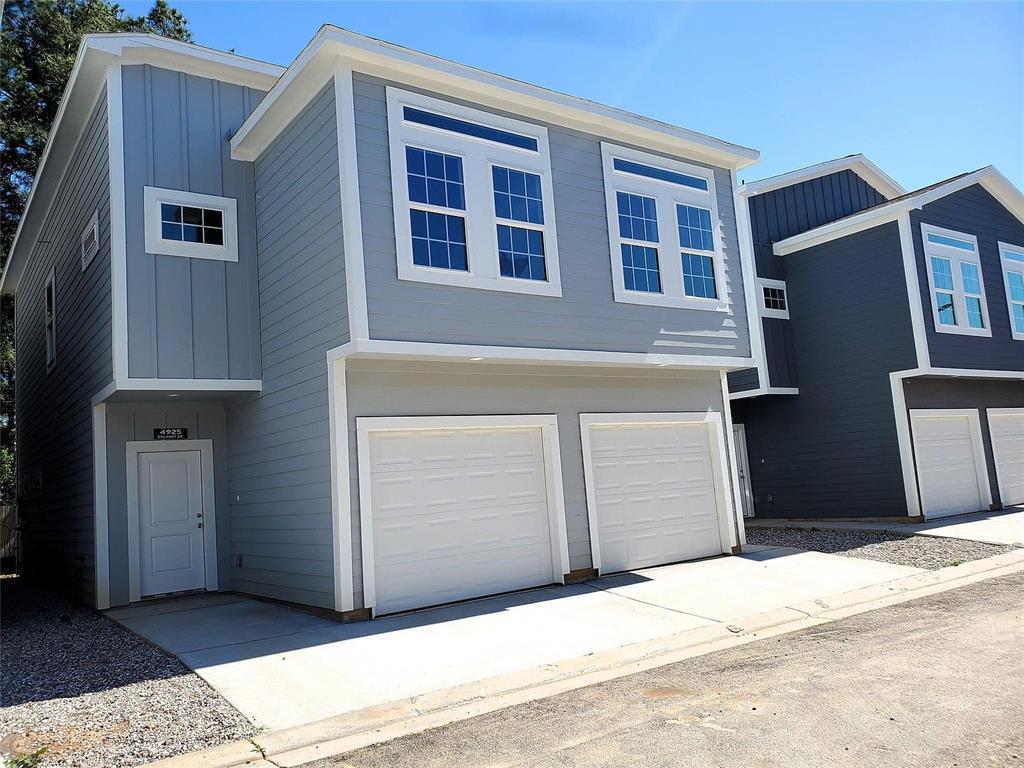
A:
[{"xmin": 0, "ymin": 579, "xmax": 256, "ymax": 768}]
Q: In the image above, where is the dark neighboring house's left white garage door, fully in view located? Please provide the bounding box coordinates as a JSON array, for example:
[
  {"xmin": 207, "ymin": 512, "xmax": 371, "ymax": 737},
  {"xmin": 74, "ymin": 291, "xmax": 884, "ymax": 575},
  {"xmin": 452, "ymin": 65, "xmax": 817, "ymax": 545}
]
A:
[{"xmin": 910, "ymin": 410, "xmax": 988, "ymax": 517}]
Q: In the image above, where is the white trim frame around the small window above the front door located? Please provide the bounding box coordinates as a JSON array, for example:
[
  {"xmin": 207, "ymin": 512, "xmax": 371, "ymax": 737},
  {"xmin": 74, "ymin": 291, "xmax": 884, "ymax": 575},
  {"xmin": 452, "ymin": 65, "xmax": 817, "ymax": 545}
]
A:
[{"xmin": 142, "ymin": 186, "xmax": 239, "ymax": 261}]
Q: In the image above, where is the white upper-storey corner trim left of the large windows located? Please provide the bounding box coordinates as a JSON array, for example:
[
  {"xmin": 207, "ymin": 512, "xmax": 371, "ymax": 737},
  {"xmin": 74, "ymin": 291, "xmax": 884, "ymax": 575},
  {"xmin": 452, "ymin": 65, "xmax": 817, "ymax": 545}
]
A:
[{"xmin": 334, "ymin": 59, "xmax": 370, "ymax": 342}]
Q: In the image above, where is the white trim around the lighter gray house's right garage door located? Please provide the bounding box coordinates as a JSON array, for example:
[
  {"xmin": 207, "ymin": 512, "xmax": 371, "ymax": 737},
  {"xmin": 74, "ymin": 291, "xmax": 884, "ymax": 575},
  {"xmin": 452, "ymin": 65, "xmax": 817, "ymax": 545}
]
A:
[{"xmin": 580, "ymin": 411, "xmax": 742, "ymax": 573}]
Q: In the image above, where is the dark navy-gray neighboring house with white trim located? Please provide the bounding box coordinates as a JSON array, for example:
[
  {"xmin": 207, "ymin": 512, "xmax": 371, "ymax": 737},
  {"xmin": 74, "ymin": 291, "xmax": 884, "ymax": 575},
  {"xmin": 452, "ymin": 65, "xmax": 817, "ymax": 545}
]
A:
[{"xmin": 729, "ymin": 156, "xmax": 1024, "ymax": 518}]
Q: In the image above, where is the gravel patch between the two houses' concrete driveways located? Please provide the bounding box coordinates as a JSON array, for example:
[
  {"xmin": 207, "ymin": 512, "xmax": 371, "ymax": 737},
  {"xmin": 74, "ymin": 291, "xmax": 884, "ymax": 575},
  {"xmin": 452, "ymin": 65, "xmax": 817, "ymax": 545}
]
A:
[{"xmin": 746, "ymin": 527, "xmax": 1014, "ymax": 570}]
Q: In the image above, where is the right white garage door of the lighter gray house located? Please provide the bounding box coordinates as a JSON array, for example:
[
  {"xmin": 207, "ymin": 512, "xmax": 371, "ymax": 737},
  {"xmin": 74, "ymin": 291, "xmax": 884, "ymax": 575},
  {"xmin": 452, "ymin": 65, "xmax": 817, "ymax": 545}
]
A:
[{"xmin": 581, "ymin": 414, "xmax": 728, "ymax": 573}]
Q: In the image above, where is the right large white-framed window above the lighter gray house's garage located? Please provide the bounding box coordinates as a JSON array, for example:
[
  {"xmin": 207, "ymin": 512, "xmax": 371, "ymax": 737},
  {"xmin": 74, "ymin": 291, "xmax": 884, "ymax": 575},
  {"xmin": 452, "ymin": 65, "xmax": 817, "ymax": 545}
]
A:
[{"xmin": 601, "ymin": 142, "xmax": 729, "ymax": 311}]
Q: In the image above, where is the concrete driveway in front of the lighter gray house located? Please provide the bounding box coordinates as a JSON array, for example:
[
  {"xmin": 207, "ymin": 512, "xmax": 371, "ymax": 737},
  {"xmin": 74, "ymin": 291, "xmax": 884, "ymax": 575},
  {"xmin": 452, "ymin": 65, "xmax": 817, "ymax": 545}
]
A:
[{"xmin": 108, "ymin": 548, "xmax": 922, "ymax": 730}]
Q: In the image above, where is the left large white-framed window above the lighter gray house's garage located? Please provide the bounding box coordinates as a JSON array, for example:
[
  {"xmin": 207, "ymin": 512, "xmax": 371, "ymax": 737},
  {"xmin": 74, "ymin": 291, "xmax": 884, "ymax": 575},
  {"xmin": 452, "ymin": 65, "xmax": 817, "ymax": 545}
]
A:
[{"xmin": 387, "ymin": 87, "xmax": 561, "ymax": 296}]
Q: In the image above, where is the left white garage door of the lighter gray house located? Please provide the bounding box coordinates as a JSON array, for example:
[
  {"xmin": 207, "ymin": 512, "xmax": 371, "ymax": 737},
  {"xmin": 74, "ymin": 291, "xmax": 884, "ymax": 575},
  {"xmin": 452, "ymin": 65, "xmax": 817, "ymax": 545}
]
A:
[{"xmin": 359, "ymin": 420, "xmax": 561, "ymax": 614}]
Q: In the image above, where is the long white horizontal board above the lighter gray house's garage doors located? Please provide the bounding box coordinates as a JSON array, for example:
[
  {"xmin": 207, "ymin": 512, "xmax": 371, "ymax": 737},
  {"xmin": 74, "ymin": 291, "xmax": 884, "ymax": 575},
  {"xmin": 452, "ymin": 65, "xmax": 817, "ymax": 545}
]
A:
[{"xmin": 328, "ymin": 339, "xmax": 754, "ymax": 371}]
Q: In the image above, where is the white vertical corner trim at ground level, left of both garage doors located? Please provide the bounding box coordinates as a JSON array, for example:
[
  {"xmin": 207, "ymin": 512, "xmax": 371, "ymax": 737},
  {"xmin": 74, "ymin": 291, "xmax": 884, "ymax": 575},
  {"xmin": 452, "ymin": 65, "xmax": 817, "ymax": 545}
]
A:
[{"xmin": 327, "ymin": 357, "xmax": 355, "ymax": 612}]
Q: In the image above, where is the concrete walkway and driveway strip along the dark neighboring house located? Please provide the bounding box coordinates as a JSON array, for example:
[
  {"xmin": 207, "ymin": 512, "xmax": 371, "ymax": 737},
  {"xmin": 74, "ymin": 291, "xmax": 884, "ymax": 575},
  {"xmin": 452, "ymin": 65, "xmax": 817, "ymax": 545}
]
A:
[{"xmin": 746, "ymin": 506, "xmax": 1024, "ymax": 547}]
